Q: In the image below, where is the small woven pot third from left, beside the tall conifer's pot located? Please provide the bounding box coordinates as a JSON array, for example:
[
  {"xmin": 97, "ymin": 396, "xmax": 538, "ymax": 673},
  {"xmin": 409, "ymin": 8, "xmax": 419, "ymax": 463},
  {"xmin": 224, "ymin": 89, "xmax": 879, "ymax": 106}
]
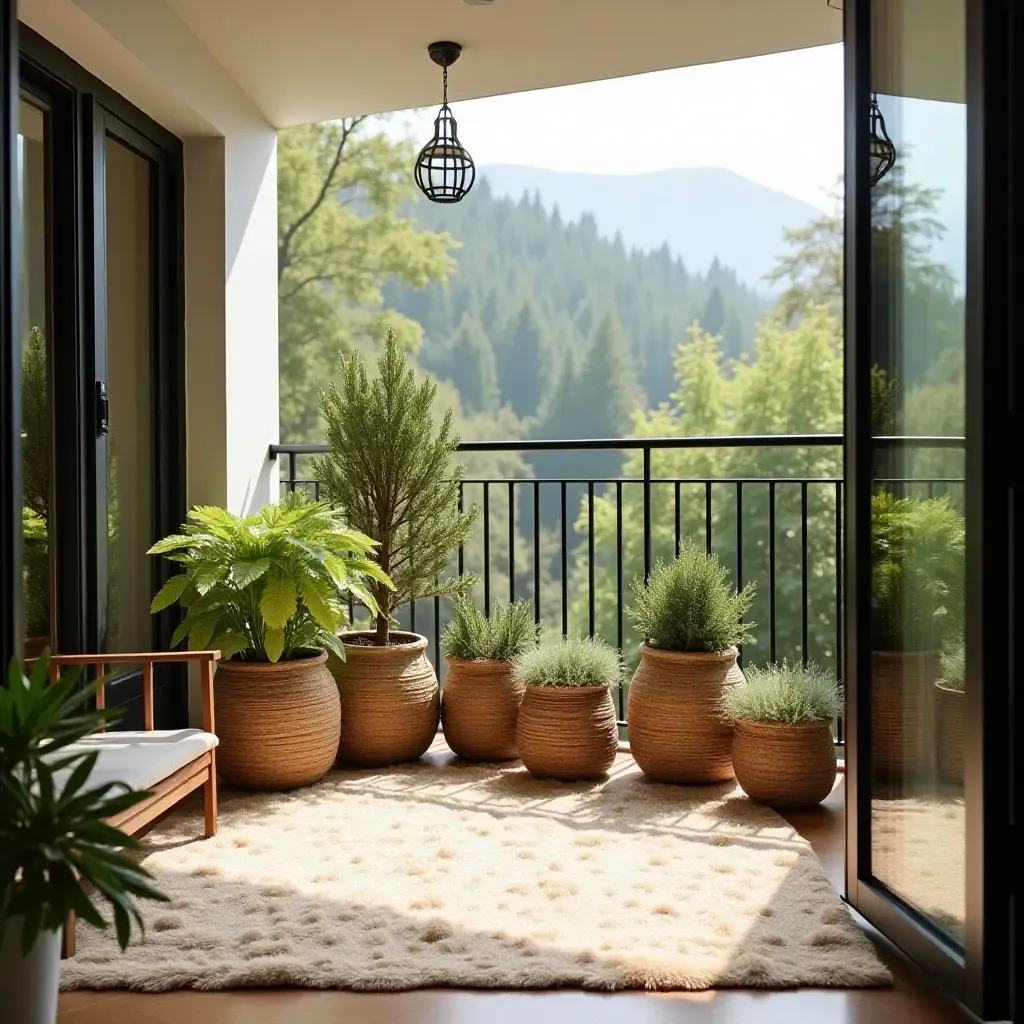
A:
[{"xmin": 441, "ymin": 657, "xmax": 525, "ymax": 761}]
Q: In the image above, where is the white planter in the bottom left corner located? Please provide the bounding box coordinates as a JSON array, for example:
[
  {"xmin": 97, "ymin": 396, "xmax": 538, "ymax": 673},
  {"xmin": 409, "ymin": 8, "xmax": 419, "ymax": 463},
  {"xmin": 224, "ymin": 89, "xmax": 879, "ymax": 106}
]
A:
[{"xmin": 0, "ymin": 918, "xmax": 60, "ymax": 1024}]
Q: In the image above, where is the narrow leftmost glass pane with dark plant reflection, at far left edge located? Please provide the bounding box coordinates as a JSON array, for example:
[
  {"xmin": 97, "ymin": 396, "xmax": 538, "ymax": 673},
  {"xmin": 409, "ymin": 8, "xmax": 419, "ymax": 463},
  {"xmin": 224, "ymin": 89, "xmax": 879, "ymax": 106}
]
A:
[{"xmin": 17, "ymin": 99, "xmax": 53, "ymax": 657}]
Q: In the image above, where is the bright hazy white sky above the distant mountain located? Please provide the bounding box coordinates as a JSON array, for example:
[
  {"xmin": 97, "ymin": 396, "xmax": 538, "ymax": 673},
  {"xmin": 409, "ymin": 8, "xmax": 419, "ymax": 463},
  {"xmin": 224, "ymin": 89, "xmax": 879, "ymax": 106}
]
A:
[{"xmin": 389, "ymin": 45, "xmax": 843, "ymax": 208}]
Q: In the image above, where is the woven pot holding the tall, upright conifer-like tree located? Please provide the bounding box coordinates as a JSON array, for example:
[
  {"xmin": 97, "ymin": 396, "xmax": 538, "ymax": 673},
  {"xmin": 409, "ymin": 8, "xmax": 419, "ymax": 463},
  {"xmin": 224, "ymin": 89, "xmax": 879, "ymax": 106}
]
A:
[{"xmin": 331, "ymin": 633, "xmax": 440, "ymax": 767}]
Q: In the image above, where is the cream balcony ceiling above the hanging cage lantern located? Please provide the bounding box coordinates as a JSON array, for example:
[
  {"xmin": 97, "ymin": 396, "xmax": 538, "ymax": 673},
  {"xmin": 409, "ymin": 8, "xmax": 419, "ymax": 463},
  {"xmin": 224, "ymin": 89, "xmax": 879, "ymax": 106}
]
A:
[{"xmin": 163, "ymin": 0, "xmax": 842, "ymax": 127}]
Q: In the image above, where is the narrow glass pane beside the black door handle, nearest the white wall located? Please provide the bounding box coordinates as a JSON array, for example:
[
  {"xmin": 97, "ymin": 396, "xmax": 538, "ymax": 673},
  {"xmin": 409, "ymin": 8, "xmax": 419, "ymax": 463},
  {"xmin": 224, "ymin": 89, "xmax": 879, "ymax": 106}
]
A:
[{"xmin": 106, "ymin": 138, "xmax": 154, "ymax": 651}]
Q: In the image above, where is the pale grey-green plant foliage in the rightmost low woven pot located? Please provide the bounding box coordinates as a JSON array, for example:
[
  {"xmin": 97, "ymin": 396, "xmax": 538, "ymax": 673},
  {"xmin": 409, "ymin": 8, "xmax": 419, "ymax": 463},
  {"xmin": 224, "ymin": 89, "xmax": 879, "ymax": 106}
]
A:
[{"xmin": 722, "ymin": 662, "xmax": 843, "ymax": 725}]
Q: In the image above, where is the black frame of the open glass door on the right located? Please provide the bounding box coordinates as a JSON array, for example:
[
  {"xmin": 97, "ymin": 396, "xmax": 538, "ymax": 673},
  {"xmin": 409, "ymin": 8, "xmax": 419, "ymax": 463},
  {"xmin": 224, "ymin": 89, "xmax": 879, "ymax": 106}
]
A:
[{"xmin": 844, "ymin": 0, "xmax": 1024, "ymax": 1019}]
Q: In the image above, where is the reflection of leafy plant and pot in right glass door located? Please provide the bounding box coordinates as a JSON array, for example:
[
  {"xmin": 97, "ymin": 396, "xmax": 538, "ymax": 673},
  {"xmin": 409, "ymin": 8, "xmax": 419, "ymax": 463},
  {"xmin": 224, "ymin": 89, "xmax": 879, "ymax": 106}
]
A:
[{"xmin": 871, "ymin": 492, "xmax": 965, "ymax": 774}]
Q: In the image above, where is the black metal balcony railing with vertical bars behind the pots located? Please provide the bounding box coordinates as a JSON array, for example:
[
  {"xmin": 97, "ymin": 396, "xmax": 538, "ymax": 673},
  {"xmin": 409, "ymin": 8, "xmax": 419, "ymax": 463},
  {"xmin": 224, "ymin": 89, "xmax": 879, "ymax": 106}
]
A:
[{"xmin": 269, "ymin": 434, "xmax": 963, "ymax": 741}]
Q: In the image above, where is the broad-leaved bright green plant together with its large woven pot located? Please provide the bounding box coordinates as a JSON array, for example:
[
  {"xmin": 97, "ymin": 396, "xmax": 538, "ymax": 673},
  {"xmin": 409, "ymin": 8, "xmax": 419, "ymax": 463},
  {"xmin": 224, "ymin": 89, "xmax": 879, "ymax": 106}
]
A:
[{"xmin": 150, "ymin": 494, "xmax": 389, "ymax": 790}]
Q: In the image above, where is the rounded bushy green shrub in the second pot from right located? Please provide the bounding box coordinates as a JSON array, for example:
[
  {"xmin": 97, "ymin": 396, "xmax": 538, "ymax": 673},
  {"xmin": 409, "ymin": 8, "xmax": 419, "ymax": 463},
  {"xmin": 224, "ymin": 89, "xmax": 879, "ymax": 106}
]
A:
[{"xmin": 629, "ymin": 542, "xmax": 754, "ymax": 653}]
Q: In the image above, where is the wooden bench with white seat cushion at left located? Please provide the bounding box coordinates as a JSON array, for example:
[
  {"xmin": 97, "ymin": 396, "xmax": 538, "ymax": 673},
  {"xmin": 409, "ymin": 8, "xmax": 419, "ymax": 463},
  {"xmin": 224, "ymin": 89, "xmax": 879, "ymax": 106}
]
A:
[{"xmin": 50, "ymin": 650, "xmax": 220, "ymax": 956}]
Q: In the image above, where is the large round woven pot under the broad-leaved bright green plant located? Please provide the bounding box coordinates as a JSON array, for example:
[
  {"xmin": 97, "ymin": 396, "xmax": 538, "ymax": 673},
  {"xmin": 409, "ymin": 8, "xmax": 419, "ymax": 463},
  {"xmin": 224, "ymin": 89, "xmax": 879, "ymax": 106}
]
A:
[{"xmin": 213, "ymin": 653, "xmax": 341, "ymax": 790}]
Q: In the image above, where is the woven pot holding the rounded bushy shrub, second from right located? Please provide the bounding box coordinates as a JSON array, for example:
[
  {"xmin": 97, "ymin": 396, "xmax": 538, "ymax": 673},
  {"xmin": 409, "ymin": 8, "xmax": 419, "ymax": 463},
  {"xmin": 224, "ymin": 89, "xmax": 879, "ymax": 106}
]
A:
[{"xmin": 627, "ymin": 644, "xmax": 742, "ymax": 784}]
